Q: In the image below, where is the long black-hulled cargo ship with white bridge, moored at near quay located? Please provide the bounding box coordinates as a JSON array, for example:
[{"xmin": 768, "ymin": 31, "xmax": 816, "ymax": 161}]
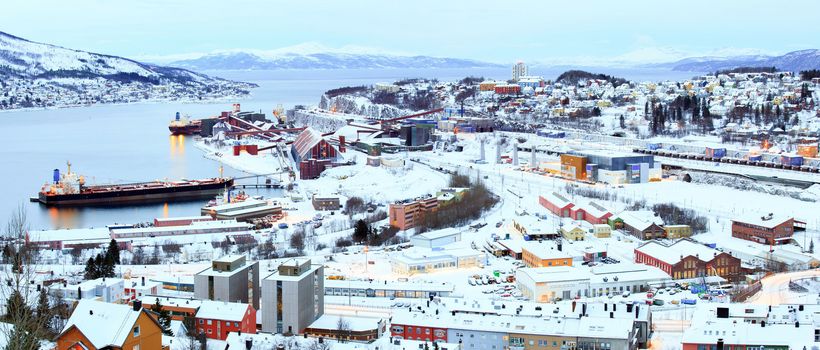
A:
[{"xmin": 37, "ymin": 163, "xmax": 233, "ymax": 206}]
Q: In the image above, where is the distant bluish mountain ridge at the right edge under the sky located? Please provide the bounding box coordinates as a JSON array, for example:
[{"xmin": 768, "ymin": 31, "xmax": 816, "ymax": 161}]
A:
[{"xmin": 651, "ymin": 49, "xmax": 820, "ymax": 72}]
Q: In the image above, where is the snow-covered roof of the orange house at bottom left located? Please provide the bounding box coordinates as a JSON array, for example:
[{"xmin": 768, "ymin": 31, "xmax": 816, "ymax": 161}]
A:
[{"xmin": 63, "ymin": 300, "xmax": 153, "ymax": 349}]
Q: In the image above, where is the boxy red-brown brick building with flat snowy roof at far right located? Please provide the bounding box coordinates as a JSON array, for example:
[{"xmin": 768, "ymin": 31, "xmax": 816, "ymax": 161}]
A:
[{"xmin": 732, "ymin": 213, "xmax": 795, "ymax": 245}]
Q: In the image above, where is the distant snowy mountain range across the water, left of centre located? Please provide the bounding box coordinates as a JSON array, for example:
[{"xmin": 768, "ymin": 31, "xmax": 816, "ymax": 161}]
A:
[{"xmin": 169, "ymin": 52, "xmax": 505, "ymax": 70}]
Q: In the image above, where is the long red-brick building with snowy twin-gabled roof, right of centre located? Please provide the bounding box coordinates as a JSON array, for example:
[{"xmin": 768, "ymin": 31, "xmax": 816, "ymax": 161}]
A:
[{"xmin": 635, "ymin": 238, "xmax": 744, "ymax": 281}]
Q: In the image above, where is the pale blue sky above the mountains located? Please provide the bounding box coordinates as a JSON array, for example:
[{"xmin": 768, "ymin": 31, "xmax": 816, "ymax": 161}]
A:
[{"xmin": 0, "ymin": 0, "xmax": 820, "ymax": 64}]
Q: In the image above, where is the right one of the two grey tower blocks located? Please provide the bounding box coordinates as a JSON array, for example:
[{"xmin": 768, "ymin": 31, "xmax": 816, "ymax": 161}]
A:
[{"xmin": 262, "ymin": 258, "xmax": 325, "ymax": 334}]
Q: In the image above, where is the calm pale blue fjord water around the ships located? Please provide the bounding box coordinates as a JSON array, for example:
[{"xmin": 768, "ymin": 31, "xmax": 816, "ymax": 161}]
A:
[{"xmin": 0, "ymin": 68, "xmax": 704, "ymax": 229}]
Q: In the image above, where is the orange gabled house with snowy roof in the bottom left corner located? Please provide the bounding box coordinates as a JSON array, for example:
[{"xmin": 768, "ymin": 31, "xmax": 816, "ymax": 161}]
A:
[{"xmin": 56, "ymin": 300, "xmax": 167, "ymax": 350}]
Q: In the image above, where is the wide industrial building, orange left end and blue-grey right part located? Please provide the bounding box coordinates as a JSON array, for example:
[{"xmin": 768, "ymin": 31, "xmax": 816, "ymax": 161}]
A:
[{"xmin": 561, "ymin": 150, "xmax": 662, "ymax": 184}]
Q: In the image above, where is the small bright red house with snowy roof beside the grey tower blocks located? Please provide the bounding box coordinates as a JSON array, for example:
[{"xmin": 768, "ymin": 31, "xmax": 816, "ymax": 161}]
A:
[{"xmin": 195, "ymin": 300, "xmax": 256, "ymax": 340}]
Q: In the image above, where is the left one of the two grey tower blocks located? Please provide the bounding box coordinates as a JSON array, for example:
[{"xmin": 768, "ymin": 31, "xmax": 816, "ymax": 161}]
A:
[{"xmin": 194, "ymin": 255, "xmax": 260, "ymax": 309}]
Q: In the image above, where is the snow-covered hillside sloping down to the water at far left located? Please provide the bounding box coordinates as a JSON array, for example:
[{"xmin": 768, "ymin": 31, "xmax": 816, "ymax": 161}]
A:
[{"xmin": 0, "ymin": 32, "xmax": 255, "ymax": 109}]
